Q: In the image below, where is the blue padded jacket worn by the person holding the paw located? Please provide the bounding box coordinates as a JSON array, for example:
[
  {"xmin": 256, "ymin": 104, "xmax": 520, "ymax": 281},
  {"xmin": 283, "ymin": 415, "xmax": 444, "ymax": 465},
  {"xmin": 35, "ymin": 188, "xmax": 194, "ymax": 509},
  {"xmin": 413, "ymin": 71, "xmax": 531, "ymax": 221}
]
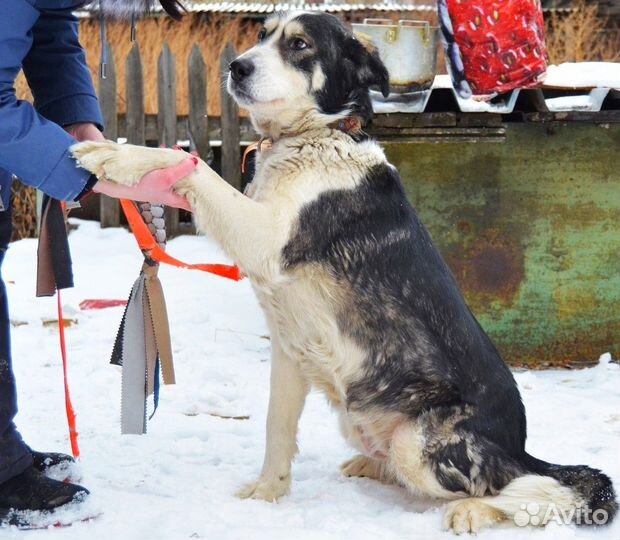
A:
[{"xmin": 0, "ymin": 0, "xmax": 103, "ymax": 207}]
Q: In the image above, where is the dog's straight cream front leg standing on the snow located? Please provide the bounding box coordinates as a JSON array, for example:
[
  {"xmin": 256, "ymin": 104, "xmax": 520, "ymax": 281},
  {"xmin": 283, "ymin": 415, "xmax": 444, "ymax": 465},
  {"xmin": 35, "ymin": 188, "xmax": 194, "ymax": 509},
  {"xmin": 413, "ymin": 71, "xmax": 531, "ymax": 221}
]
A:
[{"xmin": 237, "ymin": 334, "xmax": 309, "ymax": 501}]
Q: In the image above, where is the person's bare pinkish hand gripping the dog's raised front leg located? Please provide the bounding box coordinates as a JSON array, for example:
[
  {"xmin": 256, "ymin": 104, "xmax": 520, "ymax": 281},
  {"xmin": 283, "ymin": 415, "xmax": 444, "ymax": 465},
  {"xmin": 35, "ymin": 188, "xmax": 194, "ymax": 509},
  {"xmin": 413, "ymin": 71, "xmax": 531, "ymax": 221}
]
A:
[{"xmin": 93, "ymin": 157, "xmax": 198, "ymax": 212}]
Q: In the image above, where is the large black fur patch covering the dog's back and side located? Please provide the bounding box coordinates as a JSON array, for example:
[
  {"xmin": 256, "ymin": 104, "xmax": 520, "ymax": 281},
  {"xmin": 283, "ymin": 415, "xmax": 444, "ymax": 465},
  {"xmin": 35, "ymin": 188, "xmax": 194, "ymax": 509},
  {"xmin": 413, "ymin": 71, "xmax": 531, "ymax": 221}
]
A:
[{"xmin": 283, "ymin": 164, "xmax": 525, "ymax": 455}]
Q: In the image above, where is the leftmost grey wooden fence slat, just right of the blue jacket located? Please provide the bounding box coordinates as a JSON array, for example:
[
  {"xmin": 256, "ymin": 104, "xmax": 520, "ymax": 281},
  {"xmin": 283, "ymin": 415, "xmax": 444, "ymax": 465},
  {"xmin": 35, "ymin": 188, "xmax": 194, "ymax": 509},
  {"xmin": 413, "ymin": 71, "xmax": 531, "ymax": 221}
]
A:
[{"xmin": 99, "ymin": 43, "xmax": 121, "ymax": 228}]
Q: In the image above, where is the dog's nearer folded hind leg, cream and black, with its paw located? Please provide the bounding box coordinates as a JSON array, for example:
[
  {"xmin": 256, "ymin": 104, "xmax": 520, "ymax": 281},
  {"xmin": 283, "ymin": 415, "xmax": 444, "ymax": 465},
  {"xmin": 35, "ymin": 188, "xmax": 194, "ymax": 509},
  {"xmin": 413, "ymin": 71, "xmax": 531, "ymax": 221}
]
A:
[{"xmin": 388, "ymin": 407, "xmax": 527, "ymax": 533}]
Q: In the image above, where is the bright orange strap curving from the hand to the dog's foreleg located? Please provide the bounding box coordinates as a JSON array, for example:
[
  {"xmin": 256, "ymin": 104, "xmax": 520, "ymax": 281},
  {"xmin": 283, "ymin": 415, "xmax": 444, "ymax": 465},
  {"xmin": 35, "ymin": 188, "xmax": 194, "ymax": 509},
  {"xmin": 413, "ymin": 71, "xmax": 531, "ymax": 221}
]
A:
[{"xmin": 120, "ymin": 199, "xmax": 244, "ymax": 281}]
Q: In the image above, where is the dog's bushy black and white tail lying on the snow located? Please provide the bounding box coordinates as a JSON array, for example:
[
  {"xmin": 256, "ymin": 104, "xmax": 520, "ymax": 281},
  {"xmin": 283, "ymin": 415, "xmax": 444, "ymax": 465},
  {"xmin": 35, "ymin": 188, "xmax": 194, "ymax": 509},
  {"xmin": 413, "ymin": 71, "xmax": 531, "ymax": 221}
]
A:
[{"xmin": 485, "ymin": 454, "xmax": 618, "ymax": 525}]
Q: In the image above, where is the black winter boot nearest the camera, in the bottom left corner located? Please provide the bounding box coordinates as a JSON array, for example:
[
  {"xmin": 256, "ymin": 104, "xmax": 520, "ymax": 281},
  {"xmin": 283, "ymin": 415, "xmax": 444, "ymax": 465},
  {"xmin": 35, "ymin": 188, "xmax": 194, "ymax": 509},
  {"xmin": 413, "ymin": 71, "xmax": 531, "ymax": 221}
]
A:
[{"xmin": 0, "ymin": 465, "xmax": 89, "ymax": 511}]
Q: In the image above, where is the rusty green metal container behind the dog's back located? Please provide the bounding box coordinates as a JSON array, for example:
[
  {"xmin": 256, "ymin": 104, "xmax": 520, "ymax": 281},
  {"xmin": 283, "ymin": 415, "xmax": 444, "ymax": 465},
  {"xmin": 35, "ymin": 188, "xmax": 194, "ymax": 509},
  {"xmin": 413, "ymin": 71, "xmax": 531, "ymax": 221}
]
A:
[{"xmin": 377, "ymin": 121, "xmax": 620, "ymax": 366}]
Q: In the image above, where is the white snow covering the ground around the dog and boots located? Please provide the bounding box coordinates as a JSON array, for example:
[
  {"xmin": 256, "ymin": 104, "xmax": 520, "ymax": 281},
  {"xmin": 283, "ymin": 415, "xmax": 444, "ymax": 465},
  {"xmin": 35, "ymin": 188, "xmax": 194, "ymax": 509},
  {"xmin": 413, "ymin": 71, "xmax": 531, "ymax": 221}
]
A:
[{"xmin": 0, "ymin": 218, "xmax": 620, "ymax": 540}]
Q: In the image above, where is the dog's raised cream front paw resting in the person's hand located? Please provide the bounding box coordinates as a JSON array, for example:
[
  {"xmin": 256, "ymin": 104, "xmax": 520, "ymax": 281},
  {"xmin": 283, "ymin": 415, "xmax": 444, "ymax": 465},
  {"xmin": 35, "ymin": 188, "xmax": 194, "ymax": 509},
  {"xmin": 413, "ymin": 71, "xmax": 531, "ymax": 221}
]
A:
[{"xmin": 70, "ymin": 141, "xmax": 189, "ymax": 186}]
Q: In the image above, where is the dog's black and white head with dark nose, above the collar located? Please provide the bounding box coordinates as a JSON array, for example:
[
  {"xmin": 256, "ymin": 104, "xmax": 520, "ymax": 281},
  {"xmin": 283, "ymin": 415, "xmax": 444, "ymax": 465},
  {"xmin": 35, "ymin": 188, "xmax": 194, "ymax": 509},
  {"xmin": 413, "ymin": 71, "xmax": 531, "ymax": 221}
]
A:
[{"xmin": 228, "ymin": 12, "xmax": 389, "ymax": 135}]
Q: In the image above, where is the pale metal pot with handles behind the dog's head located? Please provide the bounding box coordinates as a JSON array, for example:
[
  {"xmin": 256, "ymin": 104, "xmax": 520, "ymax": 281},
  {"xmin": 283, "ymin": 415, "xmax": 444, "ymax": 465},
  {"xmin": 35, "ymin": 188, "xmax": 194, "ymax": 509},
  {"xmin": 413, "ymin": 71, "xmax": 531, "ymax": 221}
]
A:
[{"xmin": 353, "ymin": 19, "xmax": 439, "ymax": 94}]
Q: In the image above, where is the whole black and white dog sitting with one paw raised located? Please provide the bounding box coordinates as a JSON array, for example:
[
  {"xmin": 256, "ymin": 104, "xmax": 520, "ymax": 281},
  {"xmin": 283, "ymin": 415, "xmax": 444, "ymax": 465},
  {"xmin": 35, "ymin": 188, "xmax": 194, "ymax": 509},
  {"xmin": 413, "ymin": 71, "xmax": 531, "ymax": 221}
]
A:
[{"xmin": 73, "ymin": 13, "xmax": 617, "ymax": 533}]
